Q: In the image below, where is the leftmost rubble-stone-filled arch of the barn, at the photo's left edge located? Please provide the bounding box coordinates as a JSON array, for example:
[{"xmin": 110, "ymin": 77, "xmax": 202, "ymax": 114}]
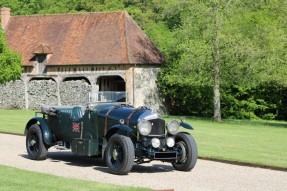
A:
[{"xmin": 0, "ymin": 80, "xmax": 25, "ymax": 109}]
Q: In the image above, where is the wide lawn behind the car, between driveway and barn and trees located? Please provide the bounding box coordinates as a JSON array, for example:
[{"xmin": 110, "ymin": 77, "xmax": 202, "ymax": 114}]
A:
[{"xmin": 0, "ymin": 110, "xmax": 287, "ymax": 169}]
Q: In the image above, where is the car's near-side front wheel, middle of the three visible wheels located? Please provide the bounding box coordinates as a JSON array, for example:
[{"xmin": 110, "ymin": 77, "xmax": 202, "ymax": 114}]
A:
[{"xmin": 105, "ymin": 134, "xmax": 135, "ymax": 175}]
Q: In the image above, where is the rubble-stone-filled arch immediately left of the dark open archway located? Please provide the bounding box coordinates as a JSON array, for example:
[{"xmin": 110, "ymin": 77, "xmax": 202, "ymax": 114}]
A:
[{"xmin": 60, "ymin": 80, "xmax": 92, "ymax": 105}]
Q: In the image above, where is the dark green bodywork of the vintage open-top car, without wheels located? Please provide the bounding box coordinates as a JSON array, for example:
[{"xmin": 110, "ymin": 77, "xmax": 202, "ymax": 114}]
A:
[{"xmin": 26, "ymin": 103, "xmax": 193, "ymax": 161}]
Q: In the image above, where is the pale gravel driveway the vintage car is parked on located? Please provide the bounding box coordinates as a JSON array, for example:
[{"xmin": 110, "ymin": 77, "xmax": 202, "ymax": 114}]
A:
[{"xmin": 0, "ymin": 134, "xmax": 287, "ymax": 191}]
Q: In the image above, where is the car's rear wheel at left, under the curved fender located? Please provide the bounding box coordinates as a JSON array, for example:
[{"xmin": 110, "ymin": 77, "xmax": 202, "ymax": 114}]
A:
[{"xmin": 26, "ymin": 124, "xmax": 48, "ymax": 160}]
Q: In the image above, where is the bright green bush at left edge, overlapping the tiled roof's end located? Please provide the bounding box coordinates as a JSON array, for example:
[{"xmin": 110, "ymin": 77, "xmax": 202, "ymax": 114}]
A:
[{"xmin": 0, "ymin": 31, "xmax": 22, "ymax": 84}]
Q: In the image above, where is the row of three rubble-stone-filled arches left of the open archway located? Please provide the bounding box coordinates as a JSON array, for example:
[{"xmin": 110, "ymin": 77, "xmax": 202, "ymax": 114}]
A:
[{"xmin": 0, "ymin": 79, "xmax": 91, "ymax": 110}]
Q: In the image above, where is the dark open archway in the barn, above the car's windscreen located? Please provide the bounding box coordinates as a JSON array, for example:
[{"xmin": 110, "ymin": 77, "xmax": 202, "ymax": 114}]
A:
[{"xmin": 97, "ymin": 76, "xmax": 126, "ymax": 92}]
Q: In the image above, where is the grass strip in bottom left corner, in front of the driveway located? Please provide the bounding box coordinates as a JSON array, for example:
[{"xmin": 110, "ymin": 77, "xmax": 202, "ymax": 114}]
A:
[{"xmin": 0, "ymin": 165, "xmax": 150, "ymax": 191}]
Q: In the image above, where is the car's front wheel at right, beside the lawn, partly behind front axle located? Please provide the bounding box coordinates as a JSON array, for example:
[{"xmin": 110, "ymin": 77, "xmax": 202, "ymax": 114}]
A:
[{"xmin": 172, "ymin": 133, "xmax": 197, "ymax": 171}]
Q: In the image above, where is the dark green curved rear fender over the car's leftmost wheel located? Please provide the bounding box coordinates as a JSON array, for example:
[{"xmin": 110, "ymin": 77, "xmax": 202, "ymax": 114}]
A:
[{"xmin": 25, "ymin": 117, "xmax": 53, "ymax": 145}]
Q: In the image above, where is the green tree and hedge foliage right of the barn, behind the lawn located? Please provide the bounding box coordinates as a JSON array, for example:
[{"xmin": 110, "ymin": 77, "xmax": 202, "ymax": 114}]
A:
[{"xmin": 158, "ymin": 0, "xmax": 287, "ymax": 119}]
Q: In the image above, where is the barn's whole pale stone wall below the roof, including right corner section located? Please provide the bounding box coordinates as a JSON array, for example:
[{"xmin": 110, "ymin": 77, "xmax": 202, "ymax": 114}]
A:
[{"xmin": 0, "ymin": 66, "xmax": 165, "ymax": 112}]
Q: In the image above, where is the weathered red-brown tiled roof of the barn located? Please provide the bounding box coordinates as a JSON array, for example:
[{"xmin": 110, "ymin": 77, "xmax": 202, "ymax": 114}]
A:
[{"xmin": 5, "ymin": 11, "xmax": 163, "ymax": 66}]
